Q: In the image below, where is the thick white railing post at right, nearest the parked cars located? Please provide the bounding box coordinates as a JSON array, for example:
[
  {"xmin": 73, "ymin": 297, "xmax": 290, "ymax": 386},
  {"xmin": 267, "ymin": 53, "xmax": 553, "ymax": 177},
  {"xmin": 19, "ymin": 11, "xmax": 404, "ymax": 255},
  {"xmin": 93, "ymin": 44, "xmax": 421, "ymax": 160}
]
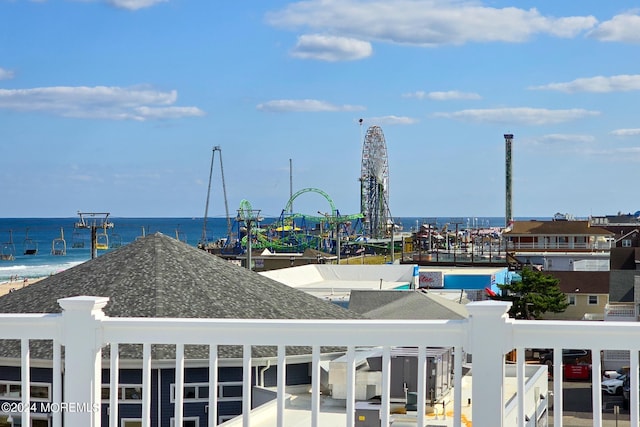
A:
[{"xmin": 467, "ymin": 301, "xmax": 513, "ymax": 427}]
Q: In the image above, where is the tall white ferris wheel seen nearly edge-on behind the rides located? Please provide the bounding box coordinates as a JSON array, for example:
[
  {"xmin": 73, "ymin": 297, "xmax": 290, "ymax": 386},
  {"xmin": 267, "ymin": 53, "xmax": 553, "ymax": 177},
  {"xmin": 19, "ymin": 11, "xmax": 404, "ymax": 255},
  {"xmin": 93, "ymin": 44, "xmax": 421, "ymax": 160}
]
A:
[{"xmin": 360, "ymin": 126, "xmax": 390, "ymax": 238}]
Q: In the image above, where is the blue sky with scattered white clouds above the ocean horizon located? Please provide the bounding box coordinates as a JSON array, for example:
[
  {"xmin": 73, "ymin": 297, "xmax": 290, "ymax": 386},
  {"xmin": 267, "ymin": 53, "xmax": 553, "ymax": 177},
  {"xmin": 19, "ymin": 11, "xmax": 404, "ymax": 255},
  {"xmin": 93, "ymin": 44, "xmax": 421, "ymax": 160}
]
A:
[{"xmin": 0, "ymin": 0, "xmax": 640, "ymax": 221}]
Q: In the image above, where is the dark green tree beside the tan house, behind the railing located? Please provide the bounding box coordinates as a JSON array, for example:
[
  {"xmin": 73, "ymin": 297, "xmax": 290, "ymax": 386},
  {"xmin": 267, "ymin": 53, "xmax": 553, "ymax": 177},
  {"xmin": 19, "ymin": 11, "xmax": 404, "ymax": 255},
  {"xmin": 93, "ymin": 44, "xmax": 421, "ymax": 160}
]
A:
[{"xmin": 493, "ymin": 267, "xmax": 569, "ymax": 319}]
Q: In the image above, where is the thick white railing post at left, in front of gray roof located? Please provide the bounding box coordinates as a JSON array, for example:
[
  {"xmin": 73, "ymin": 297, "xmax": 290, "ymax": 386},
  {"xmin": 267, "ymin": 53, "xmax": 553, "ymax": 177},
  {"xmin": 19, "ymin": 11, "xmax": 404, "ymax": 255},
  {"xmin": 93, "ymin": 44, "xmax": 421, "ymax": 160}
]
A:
[{"xmin": 58, "ymin": 296, "xmax": 109, "ymax": 427}]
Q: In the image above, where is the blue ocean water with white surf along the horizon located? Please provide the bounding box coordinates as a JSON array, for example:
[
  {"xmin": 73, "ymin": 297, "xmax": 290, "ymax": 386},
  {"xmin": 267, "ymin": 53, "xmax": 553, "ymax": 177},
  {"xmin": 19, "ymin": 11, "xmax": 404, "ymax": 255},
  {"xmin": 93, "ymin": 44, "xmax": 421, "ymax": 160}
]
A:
[{"xmin": 0, "ymin": 215, "xmax": 524, "ymax": 283}]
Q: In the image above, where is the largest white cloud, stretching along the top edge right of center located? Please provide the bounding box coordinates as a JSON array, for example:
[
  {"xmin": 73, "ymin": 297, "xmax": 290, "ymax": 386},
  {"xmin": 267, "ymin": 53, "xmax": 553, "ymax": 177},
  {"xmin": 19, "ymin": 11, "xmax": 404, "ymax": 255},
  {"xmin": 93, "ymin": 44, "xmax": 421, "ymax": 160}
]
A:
[{"xmin": 266, "ymin": 0, "xmax": 597, "ymax": 46}]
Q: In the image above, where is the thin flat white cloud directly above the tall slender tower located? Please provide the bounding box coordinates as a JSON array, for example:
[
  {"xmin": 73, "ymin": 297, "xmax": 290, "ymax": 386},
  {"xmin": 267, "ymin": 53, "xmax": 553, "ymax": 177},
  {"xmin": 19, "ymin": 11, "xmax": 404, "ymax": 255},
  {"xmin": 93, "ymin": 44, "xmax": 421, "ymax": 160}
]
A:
[{"xmin": 433, "ymin": 107, "xmax": 600, "ymax": 125}]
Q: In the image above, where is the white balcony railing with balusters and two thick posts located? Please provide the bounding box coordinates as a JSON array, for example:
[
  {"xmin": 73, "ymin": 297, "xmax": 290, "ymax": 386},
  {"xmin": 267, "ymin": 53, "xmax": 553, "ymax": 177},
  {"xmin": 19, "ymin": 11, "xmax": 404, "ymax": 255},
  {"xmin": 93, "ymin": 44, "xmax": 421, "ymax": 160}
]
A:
[{"xmin": 0, "ymin": 297, "xmax": 640, "ymax": 427}]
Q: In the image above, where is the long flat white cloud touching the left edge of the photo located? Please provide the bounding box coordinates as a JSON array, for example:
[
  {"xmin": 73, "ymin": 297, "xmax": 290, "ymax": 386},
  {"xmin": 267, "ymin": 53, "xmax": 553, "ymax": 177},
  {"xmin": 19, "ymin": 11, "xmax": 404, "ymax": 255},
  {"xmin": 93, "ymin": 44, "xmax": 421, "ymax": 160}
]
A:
[{"xmin": 0, "ymin": 86, "xmax": 204, "ymax": 121}]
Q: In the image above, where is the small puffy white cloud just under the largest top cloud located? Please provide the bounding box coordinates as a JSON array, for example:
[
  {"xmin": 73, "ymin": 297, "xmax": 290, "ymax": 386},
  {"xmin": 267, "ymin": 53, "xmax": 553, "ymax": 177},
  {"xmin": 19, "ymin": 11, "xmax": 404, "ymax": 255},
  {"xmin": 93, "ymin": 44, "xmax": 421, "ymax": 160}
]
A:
[{"xmin": 291, "ymin": 34, "xmax": 373, "ymax": 62}]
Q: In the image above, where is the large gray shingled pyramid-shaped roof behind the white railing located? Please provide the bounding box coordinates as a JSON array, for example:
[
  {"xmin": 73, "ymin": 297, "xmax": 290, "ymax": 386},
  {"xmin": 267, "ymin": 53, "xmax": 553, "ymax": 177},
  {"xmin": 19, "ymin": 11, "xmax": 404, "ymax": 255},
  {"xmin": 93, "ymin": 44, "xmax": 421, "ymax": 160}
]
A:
[{"xmin": 0, "ymin": 233, "xmax": 361, "ymax": 357}]
